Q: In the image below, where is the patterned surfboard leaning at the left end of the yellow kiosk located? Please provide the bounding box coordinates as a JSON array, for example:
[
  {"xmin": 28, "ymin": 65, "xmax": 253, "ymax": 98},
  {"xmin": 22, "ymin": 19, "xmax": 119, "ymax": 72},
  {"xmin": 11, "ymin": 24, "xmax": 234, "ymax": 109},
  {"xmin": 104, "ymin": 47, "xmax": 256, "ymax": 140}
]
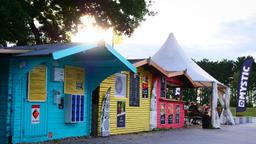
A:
[{"xmin": 100, "ymin": 87, "xmax": 111, "ymax": 136}]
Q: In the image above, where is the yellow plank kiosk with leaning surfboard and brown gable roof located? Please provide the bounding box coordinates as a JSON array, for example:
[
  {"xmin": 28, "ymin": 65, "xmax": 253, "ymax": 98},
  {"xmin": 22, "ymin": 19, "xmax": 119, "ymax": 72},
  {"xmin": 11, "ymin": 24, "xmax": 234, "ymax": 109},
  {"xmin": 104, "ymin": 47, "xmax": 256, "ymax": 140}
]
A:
[{"xmin": 92, "ymin": 59, "xmax": 168, "ymax": 136}]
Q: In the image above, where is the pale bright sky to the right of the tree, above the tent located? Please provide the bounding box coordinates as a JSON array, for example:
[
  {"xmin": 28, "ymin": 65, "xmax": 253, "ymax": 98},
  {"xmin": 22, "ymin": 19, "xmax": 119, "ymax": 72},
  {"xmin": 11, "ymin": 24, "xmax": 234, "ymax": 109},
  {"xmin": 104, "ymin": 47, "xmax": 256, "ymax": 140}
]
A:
[{"xmin": 72, "ymin": 0, "xmax": 256, "ymax": 61}]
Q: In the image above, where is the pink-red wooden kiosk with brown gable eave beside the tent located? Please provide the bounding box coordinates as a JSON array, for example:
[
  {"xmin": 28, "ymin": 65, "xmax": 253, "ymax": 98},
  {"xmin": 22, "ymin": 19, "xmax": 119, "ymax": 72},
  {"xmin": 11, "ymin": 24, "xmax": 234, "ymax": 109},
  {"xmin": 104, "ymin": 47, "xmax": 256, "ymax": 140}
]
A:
[{"xmin": 155, "ymin": 71, "xmax": 194, "ymax": 128}]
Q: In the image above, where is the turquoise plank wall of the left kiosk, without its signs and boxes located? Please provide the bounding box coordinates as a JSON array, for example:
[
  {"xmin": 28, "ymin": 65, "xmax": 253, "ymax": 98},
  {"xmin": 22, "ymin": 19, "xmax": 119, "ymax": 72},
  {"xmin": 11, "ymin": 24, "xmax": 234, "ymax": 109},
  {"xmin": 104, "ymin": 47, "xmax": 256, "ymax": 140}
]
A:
[{"xmin": 9, "ymin": 52, "xmax": 133, "ymax": 143}]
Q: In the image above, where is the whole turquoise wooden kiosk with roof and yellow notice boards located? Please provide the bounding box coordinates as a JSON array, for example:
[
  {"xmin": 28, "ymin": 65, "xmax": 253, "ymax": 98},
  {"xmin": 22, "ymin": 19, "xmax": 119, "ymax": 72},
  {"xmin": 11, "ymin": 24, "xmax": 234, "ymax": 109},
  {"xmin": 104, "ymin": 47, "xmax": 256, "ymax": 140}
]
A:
[{"xmin": 0, "ymin": 42, "xmax": 136, "ymax": 143}]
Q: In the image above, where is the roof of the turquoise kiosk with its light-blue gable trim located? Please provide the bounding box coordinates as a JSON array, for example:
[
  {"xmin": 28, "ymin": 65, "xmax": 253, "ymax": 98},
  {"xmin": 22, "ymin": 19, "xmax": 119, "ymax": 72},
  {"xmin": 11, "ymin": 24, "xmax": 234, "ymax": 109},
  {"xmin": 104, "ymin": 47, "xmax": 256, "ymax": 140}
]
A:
[{"xmin": 0, "ymin": 42, "xmax": 136, "ymax": 72}]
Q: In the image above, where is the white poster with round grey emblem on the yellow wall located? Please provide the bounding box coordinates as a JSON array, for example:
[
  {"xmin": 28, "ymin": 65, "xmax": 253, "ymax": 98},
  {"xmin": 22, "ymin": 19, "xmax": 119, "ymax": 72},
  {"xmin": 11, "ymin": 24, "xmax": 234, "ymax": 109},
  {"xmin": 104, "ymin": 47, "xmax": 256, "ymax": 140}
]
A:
[{"xmin": 115, "ymin": 73, "xmax": 126, "ymax": 98}]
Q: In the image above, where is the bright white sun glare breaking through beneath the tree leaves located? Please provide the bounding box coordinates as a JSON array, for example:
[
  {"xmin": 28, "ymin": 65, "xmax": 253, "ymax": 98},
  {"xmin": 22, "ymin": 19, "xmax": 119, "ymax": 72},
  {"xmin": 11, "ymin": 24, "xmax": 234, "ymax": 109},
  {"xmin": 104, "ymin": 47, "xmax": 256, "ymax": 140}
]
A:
[{"xmin": 71, "ymin": 16, "xmax": 112, "ymax": 44}]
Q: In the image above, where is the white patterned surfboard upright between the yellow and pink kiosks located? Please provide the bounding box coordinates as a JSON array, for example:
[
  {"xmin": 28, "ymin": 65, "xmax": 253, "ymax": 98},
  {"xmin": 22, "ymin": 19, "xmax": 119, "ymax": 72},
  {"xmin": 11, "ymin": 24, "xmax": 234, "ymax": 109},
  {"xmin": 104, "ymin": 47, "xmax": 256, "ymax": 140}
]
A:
[{"xmin": 150, "ymin": 80, "xmax": 157, "ymax": 130}]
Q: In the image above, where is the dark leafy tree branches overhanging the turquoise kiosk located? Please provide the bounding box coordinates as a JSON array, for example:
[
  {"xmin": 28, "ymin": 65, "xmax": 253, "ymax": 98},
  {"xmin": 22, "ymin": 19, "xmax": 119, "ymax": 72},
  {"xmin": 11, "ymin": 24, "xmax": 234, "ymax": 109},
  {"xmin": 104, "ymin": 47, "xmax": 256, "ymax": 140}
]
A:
[{"xmin": 0, "ymin": 0, "xmax": 155, "ymax": 46}]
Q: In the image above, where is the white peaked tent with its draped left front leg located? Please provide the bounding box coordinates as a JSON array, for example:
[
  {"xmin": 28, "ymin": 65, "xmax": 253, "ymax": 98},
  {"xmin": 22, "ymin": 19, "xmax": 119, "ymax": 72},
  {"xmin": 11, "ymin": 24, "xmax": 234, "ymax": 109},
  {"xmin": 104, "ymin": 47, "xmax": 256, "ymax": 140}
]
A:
[{"xmin": 152, "ymin": 33, "xmax": 235, "ymax": 128}]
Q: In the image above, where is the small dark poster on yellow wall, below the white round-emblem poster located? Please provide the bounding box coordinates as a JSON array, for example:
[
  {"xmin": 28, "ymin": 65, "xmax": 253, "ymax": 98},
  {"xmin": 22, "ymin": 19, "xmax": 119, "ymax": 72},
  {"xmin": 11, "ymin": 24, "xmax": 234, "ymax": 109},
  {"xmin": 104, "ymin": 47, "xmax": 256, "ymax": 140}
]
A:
[{"xmin": 117, "ymin": 101, "xmax": 126, "ymax": 127}]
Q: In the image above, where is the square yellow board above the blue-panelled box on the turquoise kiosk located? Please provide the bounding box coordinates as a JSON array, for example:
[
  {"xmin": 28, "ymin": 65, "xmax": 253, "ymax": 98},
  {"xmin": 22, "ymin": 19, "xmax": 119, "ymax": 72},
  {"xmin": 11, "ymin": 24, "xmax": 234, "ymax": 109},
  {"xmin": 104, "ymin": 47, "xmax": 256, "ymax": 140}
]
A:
[{"xmin": 64, "ymin": 66, "xmax": 84, "ymax": 95}]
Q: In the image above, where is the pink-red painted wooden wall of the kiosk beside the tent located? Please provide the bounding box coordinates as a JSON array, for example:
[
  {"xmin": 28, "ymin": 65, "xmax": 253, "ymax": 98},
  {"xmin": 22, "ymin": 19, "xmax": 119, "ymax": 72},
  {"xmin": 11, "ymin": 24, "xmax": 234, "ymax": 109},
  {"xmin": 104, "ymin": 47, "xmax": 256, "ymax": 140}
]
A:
[{"xmin": 153, "ymin": 77, "xmax": 185, "ymax": 128}]
